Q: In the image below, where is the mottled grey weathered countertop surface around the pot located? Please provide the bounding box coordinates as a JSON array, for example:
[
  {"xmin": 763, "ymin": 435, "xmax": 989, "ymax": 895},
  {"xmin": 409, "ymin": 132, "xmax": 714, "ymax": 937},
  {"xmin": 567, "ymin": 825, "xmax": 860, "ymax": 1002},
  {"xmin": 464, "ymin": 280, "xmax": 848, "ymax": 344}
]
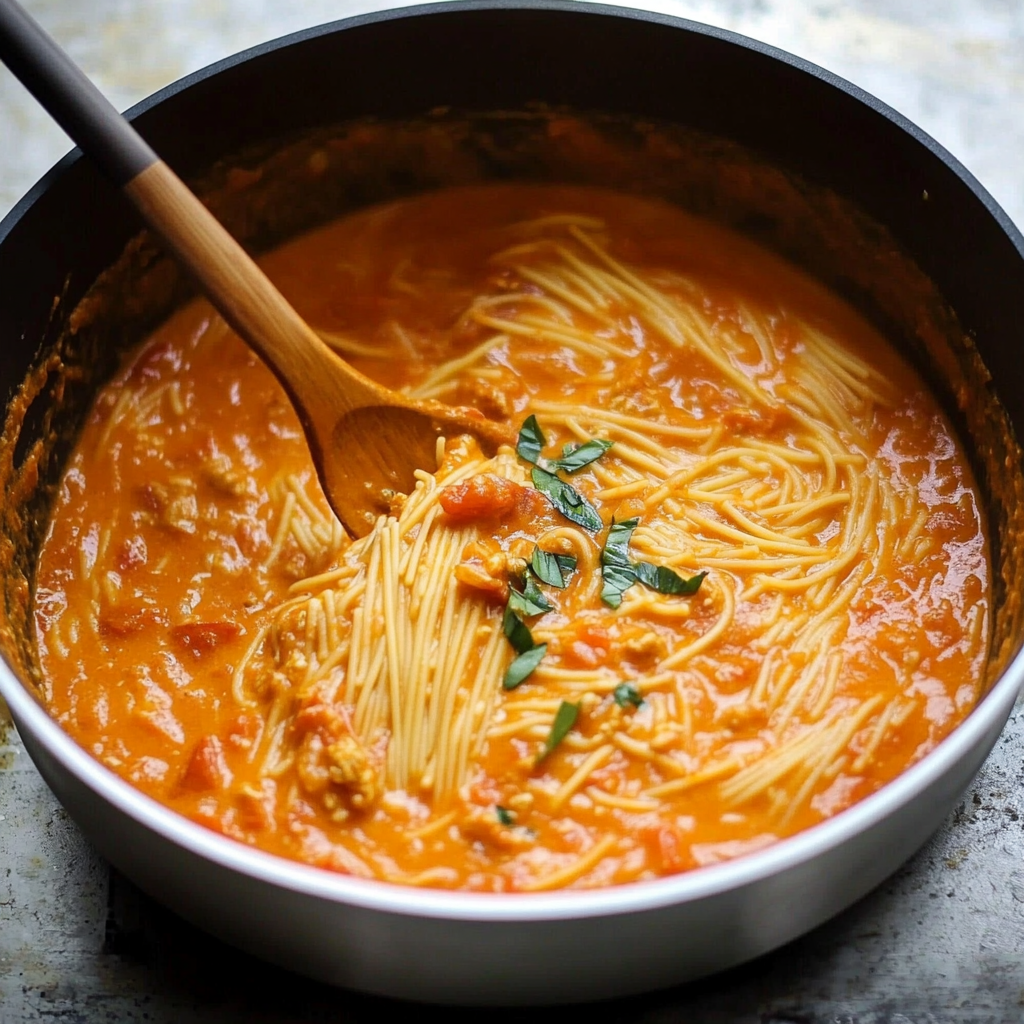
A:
[{"xmin": 0, "ymin": 0, "xmax": 1024, "ymax": 1024}]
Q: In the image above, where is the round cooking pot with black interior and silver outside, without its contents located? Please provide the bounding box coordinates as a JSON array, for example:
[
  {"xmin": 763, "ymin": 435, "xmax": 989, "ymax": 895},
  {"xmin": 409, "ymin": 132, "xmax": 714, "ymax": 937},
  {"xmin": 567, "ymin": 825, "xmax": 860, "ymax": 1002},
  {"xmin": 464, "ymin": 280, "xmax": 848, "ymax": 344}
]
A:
[{"xmin": 0, "ymin": 0, "xmax": 1024, "ymax": 1004}]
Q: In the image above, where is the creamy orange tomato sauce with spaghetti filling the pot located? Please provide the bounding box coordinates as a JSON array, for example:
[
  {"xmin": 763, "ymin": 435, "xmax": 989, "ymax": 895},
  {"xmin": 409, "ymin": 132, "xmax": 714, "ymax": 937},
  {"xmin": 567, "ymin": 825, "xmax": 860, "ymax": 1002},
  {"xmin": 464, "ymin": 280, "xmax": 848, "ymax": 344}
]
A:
[{"xmin": 36, "ymin": 185, "xmax": 989, "ymax": 891}]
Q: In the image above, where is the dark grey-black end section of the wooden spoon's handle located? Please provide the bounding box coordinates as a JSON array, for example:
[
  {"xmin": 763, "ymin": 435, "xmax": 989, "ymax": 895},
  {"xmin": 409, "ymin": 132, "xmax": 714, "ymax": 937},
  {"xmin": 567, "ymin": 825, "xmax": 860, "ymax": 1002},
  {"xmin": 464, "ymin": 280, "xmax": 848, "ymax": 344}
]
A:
[{"xmin": 0, "ymin": 0, "xmax": 158, "ymax": 186}]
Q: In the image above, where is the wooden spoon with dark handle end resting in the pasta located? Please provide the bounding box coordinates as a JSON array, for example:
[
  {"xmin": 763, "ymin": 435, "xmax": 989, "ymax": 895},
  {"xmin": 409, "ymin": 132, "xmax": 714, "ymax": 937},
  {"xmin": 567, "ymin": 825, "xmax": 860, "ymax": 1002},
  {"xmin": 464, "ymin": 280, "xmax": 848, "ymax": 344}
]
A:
[{"xmin": 0, "ymin": 0, "xmax": 513, "ymax": 537}]
